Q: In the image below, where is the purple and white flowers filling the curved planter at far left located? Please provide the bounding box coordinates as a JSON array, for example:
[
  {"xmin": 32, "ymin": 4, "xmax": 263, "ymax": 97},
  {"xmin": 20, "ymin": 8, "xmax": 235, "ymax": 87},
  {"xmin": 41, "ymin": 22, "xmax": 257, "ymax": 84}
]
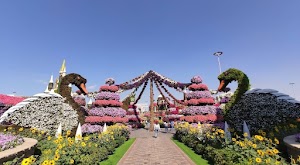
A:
[{"xmin": 0, "ymin": 133, "xmax": 24, "ymax": 151}]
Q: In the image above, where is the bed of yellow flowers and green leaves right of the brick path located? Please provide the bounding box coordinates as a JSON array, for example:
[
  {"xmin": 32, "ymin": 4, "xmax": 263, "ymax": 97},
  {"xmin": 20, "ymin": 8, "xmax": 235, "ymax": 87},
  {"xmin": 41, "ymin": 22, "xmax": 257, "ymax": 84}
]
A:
[{"xmin": 175, "ymin": 123, "xmax": 295, "ymax": 165}]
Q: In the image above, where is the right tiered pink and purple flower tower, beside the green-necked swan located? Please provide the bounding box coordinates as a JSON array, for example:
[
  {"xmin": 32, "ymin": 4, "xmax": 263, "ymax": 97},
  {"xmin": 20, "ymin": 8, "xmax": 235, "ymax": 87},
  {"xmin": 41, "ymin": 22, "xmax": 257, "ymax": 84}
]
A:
[{"xmin": 181, "ymin": 76, "xmax": 222, "ymax": 123}]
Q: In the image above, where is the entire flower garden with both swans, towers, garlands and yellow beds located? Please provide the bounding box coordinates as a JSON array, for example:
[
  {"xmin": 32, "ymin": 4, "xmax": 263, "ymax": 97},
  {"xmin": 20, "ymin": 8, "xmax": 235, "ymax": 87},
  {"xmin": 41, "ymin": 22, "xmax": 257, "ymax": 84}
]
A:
[{"xmin": 0, "ymin": 68, "xmax": 300, "ymax": 165}]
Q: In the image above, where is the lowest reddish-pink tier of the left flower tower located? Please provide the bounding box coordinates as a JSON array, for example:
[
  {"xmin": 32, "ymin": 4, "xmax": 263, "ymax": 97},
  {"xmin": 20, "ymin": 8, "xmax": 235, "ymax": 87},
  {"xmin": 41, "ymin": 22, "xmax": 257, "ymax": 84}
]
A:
[{"xmin": 85, "ymin": 116, "xmax": 128, "ymax": 123}]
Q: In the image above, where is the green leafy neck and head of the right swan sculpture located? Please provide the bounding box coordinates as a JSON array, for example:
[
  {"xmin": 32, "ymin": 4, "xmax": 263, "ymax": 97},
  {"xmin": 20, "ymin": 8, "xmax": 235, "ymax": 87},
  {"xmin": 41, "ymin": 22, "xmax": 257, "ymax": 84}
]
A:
[{"xmin": 218, "ymin": 68, "xmax": 250, "ymax": 115}]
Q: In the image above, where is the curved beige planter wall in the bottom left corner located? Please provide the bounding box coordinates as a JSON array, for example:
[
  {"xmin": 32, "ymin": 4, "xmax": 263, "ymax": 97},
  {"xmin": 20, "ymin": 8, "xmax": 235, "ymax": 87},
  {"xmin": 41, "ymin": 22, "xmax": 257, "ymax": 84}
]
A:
[{"xmin": 0, "ymin": 138, "xmax": 38, "ymax": 164}]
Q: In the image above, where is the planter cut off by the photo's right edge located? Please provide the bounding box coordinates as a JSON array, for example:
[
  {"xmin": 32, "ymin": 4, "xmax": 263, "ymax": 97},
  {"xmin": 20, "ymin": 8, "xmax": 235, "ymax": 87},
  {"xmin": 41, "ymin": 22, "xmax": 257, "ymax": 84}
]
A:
[{"xmin": 283, "ymin": 135, "xmax": 300, "ymax": 160}]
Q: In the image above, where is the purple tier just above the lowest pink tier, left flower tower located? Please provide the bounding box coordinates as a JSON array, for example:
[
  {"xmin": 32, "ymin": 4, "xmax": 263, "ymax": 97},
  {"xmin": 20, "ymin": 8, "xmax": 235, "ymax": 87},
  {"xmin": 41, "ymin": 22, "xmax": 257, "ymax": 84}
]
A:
[{"xmin": 88, "ymin": 107, "xmax": 126, "ymax": 117}]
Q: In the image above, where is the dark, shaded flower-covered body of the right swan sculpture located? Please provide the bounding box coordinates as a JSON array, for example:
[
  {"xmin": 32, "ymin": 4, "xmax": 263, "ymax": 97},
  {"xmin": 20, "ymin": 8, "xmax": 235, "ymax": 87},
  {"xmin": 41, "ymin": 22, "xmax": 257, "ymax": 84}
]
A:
[{"xmin": 228, "ymin": 89, "xmax": 300, "ymax": 131}]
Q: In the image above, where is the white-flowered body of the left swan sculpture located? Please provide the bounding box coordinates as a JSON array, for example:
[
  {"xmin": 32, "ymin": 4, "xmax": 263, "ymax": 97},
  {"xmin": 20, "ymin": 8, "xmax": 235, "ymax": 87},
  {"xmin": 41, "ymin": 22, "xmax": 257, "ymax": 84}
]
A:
[{"xmin": 4, "ymin": 96, "xmax": 78, "ymax": 132}]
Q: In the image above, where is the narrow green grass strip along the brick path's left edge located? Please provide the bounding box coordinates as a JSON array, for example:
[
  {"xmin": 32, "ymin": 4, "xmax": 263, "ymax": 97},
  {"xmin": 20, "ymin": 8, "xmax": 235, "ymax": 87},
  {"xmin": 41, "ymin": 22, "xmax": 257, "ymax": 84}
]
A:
[{"xmin": 100, "ymin": 138, "xmax": 135, "ymax": 165}]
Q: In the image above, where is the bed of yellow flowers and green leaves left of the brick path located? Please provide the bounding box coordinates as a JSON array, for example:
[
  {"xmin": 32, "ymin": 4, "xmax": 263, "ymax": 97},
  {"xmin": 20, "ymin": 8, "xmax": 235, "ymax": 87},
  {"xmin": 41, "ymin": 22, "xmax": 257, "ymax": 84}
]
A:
[{"xmin": 0, "ymin": 124, "xmax": 130, "ymax": 165}]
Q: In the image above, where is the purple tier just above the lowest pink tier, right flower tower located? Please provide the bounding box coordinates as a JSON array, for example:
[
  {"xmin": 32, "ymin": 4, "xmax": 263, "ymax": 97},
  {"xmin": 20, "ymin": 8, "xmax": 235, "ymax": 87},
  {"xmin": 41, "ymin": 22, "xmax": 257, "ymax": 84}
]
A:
[{"xmin": 181, "ymin": 105, "xmax": 222, "ymax": 116}]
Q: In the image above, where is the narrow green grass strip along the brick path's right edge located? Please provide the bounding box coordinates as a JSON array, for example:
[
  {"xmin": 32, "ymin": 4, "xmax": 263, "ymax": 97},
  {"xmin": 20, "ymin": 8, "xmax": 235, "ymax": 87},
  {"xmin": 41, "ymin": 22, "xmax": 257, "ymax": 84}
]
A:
[{"xmin": 172, "ymin": 139, "xmax": 209, "ymax": 165}]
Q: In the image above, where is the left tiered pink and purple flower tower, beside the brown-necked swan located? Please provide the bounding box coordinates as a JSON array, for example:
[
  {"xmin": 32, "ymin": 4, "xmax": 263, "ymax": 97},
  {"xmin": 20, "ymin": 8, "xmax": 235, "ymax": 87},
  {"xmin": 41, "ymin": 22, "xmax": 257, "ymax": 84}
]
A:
[{"xmin": 85, "ymin": 78, "xmax": 128, "ymax": 127}]
